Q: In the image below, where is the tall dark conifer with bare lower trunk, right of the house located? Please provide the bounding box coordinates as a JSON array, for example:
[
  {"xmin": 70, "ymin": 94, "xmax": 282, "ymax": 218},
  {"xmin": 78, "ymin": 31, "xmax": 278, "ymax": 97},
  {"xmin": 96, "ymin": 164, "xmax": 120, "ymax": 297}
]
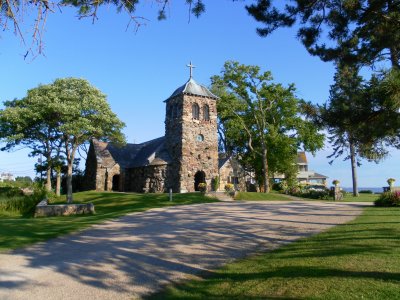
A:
[{"xmin": 317, "ymin": 65, "xmax": 387, "ymax": 197}]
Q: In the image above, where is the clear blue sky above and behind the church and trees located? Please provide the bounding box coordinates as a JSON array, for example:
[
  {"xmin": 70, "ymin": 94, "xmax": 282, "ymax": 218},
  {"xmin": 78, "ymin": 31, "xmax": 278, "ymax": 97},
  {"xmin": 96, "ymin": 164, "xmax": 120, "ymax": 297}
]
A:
[{"xmin": 0, "ymin": 0, "xmax": 400, "ymax": 187}]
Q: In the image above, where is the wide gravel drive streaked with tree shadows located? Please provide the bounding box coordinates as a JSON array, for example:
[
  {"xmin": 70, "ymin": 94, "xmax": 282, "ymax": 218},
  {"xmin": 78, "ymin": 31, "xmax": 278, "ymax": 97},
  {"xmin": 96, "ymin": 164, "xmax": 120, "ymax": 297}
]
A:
[{"xmin": 0, "ymin": 201, "xmax": 368, "ymax": 300}]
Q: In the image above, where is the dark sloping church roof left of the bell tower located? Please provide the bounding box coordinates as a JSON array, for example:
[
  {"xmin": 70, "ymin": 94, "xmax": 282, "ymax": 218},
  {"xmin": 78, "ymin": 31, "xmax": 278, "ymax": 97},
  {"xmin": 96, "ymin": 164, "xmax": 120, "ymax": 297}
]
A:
[{"xmin": 92, "ymin": 137, "xmax": 171, "ymax": 168}]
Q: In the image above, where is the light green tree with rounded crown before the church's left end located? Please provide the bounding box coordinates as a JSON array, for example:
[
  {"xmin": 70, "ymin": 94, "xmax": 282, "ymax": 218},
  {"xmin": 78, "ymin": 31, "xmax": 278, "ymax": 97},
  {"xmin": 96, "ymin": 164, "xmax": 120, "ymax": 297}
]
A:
[{"xmin": 43, "ymin": 78, "xmax": 125, "ymax": 202}]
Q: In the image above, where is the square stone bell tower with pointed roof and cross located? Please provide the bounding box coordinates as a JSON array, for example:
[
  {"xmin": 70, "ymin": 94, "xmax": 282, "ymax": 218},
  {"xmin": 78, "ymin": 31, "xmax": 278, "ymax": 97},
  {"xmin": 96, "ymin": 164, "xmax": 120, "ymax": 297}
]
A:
[{"xmin": 165, "ymin": 63, "xmax": 218, "ymax": 193}]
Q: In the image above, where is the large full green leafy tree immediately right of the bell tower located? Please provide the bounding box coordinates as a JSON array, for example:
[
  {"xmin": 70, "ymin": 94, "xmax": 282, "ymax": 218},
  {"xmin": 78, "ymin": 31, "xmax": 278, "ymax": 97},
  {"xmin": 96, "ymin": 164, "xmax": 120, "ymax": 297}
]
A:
[{"xmin": 211, "ymin": 61, "xmax": 323, "ymax": 192}]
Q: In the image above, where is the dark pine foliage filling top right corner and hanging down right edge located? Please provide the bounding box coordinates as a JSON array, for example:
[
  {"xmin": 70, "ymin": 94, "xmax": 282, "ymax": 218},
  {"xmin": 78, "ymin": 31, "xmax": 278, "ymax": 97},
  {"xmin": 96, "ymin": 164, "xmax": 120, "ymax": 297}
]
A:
[{"xmin": 247, "ymin": 0, "xmax": 400, "ymax": 157}]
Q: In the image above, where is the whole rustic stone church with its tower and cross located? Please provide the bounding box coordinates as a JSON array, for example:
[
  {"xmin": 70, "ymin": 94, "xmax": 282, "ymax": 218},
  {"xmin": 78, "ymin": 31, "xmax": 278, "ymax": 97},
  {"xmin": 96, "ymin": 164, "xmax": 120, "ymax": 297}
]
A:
[{"xmin": 85, "ymin": 65, "xmax": 244, "ymax": 193}]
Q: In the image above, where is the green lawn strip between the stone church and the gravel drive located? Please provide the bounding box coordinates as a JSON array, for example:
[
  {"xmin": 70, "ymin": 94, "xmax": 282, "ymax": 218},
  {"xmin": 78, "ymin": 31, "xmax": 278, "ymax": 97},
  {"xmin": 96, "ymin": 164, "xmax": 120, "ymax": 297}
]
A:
[{"xmin": 0, "ymin": 192, "xmax": 216, "ymax": 251}]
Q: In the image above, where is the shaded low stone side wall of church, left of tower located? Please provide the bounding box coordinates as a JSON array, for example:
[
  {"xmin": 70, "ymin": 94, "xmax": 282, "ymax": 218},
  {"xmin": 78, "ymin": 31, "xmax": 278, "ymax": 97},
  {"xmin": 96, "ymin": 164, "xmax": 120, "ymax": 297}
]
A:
[{"xmin": 125, "ymin": 165, "xmax": 168, "ymax": 193}]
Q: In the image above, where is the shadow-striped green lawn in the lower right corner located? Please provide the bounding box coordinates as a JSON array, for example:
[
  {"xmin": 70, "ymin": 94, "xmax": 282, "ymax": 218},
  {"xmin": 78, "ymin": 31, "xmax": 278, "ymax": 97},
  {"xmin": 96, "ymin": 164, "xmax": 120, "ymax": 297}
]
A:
[{"xmin": 150, "ymin": 207, "xmax": 400, "ymax": 299}]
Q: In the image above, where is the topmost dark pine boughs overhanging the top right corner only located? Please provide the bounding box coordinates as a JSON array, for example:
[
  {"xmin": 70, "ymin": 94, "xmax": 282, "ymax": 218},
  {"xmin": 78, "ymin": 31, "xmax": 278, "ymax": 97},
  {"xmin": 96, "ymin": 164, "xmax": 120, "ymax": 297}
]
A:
[{"xmin": 247, "ymin": 0, "xmax": 400, "ymax": 69}]
